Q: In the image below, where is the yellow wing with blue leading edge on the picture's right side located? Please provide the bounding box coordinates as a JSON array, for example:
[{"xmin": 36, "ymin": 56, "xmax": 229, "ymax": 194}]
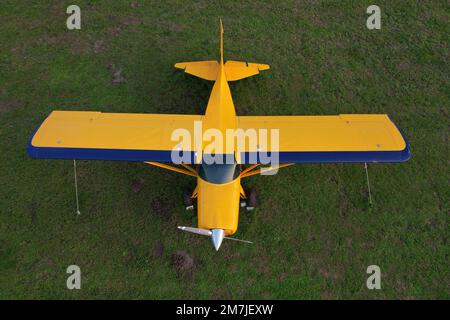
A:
[{"xmin": 237, "ymin": 114, "xmax": 410, "ymax": 163}]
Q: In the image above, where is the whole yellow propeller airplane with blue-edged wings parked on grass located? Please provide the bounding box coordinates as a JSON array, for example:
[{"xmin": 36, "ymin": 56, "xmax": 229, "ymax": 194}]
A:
[{"xmin": 27, "ymin": 21, "xmax": 410, "ymax": 250}]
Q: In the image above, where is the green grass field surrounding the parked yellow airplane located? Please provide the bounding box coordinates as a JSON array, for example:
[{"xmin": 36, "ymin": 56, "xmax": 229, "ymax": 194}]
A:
[{"xmin": 0, "ymin": 0, "xmax": 450, "ymax": 299}]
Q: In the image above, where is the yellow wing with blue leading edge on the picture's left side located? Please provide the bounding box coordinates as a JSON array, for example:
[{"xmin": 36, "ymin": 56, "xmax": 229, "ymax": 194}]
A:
[{"xmin": 28, "ymin": 111, "xmax": 202, "ymax": 162}]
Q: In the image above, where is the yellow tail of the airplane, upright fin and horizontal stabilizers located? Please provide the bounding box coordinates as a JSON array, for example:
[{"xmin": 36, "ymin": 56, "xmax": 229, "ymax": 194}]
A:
[{"xmin": 175, "ymin": 18, "xmax": 270, "ymax": 81}]
